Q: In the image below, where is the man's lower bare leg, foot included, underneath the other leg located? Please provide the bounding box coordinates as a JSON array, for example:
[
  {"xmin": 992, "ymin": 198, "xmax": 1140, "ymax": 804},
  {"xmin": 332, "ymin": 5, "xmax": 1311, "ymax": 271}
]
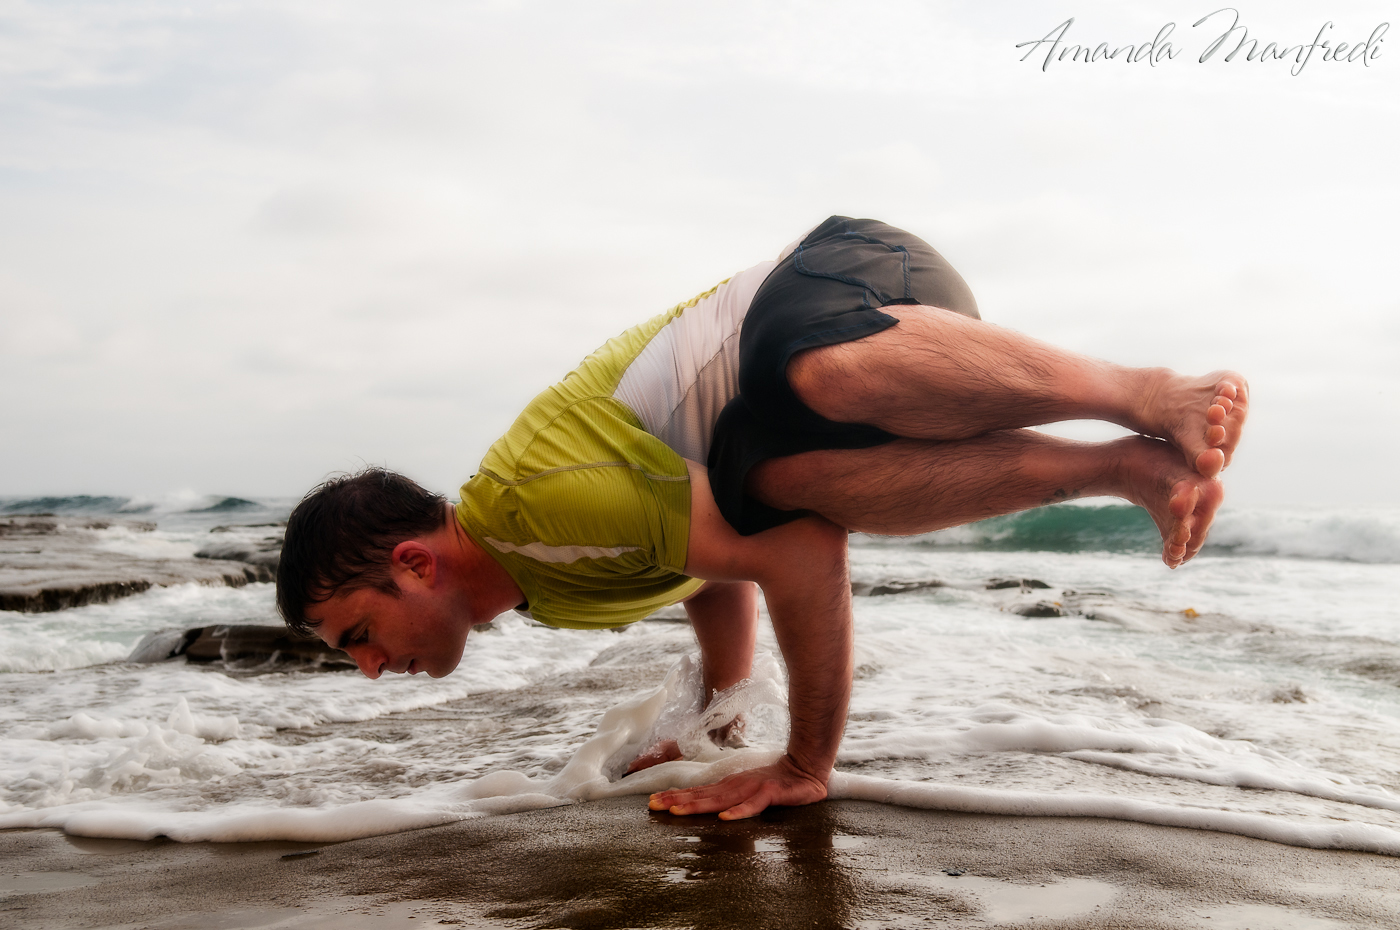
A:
[{"xmin": 746, "ymin": 430, "xmax": 1222, "ymax": 569}]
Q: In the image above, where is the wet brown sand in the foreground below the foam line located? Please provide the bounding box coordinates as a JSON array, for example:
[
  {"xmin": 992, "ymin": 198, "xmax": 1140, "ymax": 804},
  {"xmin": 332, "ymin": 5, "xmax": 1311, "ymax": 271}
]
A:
[{"xmin": 0, "ymin": 798, "xmax": 1400, "ymax": 930}]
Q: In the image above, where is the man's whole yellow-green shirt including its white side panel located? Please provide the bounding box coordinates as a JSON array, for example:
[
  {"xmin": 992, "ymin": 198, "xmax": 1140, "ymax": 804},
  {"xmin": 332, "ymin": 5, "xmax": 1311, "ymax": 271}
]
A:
[{"xmin": 456, "ymin": 242, "xmax": 797, "ymax": 627}]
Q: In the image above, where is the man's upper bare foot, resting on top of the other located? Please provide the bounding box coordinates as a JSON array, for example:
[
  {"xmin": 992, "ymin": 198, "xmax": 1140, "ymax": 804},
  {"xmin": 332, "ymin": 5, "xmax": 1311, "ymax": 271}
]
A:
[{"xmin": 1134, "ymin": 368, "xmax": 1249, "ymax": 478}]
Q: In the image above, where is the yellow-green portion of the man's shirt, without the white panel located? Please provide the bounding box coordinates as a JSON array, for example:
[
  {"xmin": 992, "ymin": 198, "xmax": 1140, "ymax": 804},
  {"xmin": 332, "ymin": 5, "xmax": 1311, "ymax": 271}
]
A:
[{"xmin": 456, "ymin": 298, "xmax": 703, "ymax": 629}]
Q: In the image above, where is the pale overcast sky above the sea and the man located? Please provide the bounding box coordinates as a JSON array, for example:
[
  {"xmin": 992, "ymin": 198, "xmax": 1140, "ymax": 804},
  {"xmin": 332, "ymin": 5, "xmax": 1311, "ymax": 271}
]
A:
[{"xmin": 0, "ymin": 0, "xmax": 1400, "ymax": 506}]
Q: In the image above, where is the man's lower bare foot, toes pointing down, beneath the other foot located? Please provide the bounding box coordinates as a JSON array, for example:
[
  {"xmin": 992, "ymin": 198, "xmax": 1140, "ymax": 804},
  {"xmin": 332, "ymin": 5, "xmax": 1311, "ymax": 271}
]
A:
[{"xmin": 1119, "ymin": 436, "xmax": 1225, "ymax": 569}]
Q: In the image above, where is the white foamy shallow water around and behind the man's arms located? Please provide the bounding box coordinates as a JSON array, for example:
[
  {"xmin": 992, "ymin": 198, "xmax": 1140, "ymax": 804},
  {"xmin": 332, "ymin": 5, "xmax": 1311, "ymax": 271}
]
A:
[{"xmin": 0, "ymin": 501, "xmax": 1400, "ymax": 854}]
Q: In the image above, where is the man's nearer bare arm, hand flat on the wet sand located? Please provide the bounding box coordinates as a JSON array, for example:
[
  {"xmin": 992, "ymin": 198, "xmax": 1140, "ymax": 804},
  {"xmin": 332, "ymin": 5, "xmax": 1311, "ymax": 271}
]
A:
[{"xmin": 651, "ymin": 464, "xmax": 853, "ymax": 819}]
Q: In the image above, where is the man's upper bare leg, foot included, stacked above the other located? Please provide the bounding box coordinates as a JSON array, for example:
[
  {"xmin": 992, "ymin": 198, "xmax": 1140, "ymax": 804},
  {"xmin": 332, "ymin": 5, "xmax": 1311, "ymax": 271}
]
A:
[{"xmin": 787, "ymin": 307, "xmax": 1249, "ymax": 478}]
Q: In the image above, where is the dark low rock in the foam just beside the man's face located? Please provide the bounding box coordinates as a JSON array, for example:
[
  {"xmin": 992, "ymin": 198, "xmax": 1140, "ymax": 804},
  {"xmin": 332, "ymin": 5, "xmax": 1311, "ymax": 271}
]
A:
[{"xmin": 126, "ymin": 623, "xmax": 356, "ymax": 668}]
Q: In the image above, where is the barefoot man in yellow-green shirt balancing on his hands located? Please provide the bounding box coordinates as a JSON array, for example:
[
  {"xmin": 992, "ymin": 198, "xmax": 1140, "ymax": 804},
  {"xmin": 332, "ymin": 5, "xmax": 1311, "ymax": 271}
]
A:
[{"xmin": 277, "ymin": 217, "xmax": 1247, "ymax": 819}]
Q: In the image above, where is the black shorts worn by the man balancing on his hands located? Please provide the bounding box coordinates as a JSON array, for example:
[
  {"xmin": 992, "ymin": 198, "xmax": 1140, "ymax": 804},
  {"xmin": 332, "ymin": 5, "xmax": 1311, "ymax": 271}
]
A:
[{"xmin": 707, "ymin": 216, "xmax": 980, "ymax": 536}]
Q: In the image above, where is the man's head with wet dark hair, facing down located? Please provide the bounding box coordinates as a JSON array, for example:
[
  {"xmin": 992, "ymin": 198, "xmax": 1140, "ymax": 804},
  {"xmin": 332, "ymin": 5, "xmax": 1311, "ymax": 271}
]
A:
[{"xmin": 277, "ymin": 468, "xmax": 455, "ymax": 678}]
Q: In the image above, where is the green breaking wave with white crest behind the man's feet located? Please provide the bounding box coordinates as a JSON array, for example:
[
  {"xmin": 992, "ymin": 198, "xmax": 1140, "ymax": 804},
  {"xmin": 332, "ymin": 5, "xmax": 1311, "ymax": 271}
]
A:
[{"xmin": 871, "ymin": 504, "xmax": 1400, "ymax": 563}]
